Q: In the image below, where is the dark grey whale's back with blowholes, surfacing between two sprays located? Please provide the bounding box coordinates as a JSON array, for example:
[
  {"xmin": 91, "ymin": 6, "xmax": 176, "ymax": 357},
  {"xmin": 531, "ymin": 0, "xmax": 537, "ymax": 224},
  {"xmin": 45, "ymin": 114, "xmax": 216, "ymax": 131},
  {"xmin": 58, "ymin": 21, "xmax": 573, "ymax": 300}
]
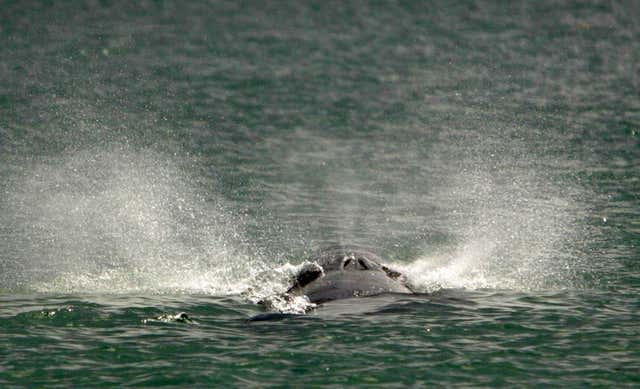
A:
[{"xmin": 287, "ymin": 246, "xmax": 413, "ymax": 304}]
